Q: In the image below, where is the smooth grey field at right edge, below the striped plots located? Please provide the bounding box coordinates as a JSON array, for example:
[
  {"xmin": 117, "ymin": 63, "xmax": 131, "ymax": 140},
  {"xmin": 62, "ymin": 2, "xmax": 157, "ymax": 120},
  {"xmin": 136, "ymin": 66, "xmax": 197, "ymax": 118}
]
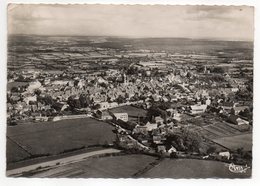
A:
[{"xmin": 213, "ymin": 134, "xmax": 252, "ymax": 151}]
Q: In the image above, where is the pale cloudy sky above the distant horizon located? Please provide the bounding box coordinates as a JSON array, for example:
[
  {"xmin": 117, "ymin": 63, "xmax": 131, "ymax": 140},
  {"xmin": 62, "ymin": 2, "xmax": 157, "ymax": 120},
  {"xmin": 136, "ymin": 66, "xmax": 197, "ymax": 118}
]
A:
[{"xmin": 8, "ymin": 4, "xmax": 254, "ymax": 41}]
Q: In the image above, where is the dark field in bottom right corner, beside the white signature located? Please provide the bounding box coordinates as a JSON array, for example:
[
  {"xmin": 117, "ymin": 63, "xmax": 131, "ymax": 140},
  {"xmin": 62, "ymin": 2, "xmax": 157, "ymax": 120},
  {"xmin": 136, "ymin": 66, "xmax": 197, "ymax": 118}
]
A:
[{"xmin": 141, "ymin": 159, "xmax": 251, "ymax": 178}]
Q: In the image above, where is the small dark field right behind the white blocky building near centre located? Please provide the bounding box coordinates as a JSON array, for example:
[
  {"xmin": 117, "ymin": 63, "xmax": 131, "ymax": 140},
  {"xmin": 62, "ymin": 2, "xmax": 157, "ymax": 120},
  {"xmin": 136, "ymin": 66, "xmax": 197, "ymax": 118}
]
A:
[{"xmin": 110, "ymin": 105, "xmax": 147, "ymax": 121}]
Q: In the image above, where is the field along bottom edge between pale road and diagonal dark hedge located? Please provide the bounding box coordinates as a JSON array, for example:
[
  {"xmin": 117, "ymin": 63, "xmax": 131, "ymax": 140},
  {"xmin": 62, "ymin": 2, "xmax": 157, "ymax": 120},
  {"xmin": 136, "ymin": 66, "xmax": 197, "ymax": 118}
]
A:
[{"xmin": 26, "ymin": 155, "xmax": 155, "ymax": 178}]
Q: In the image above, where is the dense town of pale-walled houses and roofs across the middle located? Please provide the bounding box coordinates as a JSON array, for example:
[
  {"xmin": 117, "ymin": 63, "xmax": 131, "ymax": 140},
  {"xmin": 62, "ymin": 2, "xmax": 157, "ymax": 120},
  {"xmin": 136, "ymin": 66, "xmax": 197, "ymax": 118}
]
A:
[{"xmin": 7, "ymin": 53, "xmax": 252, "ymax": 126}]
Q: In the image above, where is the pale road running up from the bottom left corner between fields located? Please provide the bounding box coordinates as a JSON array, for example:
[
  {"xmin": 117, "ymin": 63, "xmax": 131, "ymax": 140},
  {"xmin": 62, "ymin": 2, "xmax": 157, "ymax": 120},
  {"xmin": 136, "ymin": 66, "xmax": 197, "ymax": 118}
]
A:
[{"xmin": 6, "ymin": 148, "xmax": 121, "ymax": 177}]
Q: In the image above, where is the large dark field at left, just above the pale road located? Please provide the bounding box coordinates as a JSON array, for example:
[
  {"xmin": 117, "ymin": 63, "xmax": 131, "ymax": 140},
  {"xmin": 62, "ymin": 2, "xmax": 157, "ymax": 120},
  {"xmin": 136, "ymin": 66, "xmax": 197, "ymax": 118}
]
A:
[{"xmin": 7, "ymin": 118, "xmax": 115, "ymax": 163}]
